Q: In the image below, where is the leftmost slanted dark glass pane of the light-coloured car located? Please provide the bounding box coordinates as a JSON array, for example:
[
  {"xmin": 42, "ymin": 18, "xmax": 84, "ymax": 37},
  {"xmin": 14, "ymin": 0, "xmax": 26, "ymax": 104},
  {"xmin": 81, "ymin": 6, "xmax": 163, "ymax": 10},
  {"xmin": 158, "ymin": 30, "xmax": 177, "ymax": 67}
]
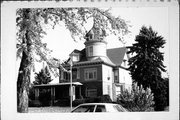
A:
[{"xmin": 72, "ymin": 105, "xmax": 95, "ymax": 112}]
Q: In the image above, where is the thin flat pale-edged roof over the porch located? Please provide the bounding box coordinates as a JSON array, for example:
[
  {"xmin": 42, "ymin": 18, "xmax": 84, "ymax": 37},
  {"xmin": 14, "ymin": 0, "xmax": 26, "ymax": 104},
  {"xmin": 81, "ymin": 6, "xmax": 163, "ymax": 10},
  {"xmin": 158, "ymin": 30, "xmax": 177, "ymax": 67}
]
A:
[{"xmin": 33, "ymin": 82, "xmax": 83, "ymax": 87}]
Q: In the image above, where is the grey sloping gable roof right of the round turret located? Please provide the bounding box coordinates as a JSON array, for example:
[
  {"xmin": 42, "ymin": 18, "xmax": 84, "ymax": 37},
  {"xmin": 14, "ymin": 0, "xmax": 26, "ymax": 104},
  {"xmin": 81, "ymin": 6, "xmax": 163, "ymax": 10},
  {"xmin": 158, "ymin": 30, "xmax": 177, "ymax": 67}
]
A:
[{"xmin": 107, "ymin": 47, "xmax": 127, "ymax": 66}]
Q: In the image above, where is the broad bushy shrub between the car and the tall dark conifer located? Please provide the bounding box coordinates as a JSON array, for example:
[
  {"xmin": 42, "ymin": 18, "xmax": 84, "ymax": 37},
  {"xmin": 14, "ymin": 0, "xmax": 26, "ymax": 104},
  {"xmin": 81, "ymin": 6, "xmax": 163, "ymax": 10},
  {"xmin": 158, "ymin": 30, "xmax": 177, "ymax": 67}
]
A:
[{"xmin": 117, "ymin": 83, "xmax": 154, "ymax": 111}]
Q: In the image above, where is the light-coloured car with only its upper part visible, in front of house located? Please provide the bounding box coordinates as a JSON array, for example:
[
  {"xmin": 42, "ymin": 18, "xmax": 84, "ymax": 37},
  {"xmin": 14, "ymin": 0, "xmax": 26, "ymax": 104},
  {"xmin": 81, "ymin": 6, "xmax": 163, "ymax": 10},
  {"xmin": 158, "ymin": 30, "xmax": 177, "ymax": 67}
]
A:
[{"xmin": 71, "ymin": 103, "xmax": 128, "ymax": 113}]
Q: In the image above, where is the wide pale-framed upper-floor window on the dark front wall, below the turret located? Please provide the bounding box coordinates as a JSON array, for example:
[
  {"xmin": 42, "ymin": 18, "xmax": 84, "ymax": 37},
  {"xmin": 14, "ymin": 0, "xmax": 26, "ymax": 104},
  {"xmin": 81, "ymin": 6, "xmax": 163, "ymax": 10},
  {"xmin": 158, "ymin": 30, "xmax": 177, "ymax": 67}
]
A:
[{"xmin": 84, "ymin": 68, "xmax": 97, "ymax": 80}]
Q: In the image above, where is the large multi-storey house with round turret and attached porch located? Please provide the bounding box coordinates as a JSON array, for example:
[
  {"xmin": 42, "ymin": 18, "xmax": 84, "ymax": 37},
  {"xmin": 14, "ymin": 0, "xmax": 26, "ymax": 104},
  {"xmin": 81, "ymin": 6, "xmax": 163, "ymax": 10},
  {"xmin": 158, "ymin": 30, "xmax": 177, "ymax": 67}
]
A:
[{"xmin": 35, "ymin": 22, "xmax": 132, "ymax": 105}]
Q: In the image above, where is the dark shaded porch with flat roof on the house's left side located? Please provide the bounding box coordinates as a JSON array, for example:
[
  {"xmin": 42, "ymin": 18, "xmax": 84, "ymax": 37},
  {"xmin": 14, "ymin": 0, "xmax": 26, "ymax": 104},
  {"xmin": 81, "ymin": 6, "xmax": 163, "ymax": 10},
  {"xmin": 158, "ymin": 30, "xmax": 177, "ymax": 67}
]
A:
[{"xmin": 34, "ymin": 82, "xmax": 82, "ymax": 106}]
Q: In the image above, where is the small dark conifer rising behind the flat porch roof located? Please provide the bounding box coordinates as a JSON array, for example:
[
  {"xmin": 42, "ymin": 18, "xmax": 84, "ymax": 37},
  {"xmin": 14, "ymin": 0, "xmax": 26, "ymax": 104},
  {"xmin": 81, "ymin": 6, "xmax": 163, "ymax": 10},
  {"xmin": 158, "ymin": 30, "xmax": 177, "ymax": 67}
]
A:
[{"xmin": 33, "ymin": 66, "xmax": 52, "ymax": 85}]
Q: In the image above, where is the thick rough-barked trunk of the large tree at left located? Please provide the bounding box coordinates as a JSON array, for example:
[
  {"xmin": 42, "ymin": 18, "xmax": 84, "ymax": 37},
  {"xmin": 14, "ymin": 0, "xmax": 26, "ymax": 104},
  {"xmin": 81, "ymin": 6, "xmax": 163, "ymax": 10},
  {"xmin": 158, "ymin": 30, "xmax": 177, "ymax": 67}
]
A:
[{"xmin": 17, "ymin": 31, "xmax": 31, "ymax": 113}]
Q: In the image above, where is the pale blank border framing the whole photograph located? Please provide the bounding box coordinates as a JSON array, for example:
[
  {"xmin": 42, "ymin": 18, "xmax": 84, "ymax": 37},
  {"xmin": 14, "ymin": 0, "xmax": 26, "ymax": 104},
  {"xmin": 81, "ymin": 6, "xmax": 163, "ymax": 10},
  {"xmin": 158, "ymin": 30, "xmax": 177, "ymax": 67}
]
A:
[{"xmin": 1, "ymin": 0, "xmax": 179, "ymax": 120}]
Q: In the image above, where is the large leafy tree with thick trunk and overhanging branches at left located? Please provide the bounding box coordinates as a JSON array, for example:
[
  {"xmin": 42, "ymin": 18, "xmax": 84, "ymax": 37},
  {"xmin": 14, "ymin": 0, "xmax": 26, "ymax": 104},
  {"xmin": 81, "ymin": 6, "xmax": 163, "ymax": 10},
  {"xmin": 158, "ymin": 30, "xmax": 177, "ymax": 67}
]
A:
[{"xmin": 16, "ymin": 8, "xmax": 129, "ymax": 112}]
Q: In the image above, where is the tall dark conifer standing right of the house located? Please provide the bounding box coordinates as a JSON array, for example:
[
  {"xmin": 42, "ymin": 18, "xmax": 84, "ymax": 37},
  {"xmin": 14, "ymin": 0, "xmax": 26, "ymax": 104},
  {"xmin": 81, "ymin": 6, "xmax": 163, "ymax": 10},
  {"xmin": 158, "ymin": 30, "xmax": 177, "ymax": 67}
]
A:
[{"xmin": 128, "ymin": 26, "xmax": 167, "ymax": 111}]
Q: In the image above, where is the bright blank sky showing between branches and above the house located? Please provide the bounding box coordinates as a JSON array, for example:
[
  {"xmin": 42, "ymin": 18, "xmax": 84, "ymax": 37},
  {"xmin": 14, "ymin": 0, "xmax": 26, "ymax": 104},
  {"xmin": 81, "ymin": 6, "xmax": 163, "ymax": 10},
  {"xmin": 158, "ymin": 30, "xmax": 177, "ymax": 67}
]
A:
[{"xmin": 34, "ymin": 7, "xmax": 169, "ymax": 81}]
